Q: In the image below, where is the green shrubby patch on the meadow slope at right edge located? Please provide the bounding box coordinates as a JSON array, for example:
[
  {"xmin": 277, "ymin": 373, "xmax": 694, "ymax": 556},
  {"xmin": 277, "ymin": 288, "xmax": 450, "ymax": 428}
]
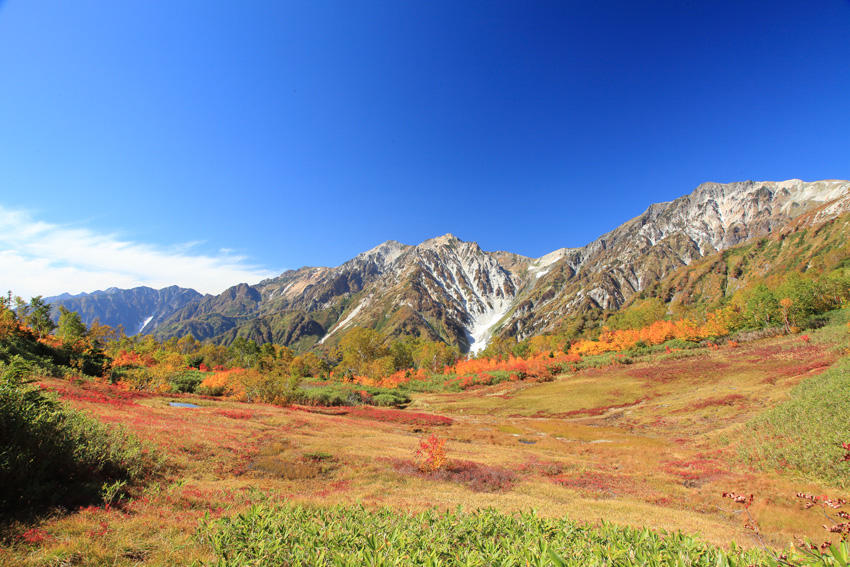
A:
[{"xmin": 741, "ymin": 357, "xmax": 850, "ymax": 488}]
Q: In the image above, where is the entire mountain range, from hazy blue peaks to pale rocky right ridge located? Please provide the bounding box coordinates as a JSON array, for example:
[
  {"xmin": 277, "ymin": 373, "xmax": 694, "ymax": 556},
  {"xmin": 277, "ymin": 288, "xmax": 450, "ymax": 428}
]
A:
[{"xmin": 44, "ymin": 179, "xmax": 850, "ymax": 352}]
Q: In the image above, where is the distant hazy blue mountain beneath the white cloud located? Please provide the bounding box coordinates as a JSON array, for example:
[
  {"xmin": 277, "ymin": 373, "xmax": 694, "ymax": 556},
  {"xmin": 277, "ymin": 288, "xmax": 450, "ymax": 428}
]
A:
[{"xmin": 46, "ymin": 286, "xmax": 202, "ymax": 335}]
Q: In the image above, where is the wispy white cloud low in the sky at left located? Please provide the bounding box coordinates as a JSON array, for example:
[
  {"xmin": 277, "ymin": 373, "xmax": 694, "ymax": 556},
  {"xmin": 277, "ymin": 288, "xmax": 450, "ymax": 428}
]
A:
[{"xmin": 0, "ymin": 206, "xmax": 275, "ymax": 297}]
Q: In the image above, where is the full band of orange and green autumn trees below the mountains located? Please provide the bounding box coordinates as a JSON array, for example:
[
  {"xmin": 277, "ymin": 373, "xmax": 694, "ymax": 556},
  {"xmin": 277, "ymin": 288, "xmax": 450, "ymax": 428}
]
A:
[{"xmin": 0, "ymin": 273, "xmax": 850, "ymax": 402}]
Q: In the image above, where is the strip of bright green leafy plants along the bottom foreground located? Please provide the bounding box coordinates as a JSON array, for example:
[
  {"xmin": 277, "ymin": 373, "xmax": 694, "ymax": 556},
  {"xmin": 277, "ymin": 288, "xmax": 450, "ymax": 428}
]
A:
[{"xmin": 199, "ymin": 505, "xmax": 775, "ymax": 567}]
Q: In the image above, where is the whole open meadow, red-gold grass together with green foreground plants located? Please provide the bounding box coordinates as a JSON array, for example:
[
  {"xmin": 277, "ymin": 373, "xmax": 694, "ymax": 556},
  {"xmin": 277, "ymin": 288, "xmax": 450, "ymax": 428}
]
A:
[{"xmin": 0, "ymin": 320, "xmax": 850, "ymax": 566}]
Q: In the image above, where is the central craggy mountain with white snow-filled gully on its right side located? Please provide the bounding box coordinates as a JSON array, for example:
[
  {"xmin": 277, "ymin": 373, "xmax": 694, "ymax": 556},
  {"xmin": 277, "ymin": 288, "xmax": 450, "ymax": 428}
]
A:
[{"xmin": 156, "ymin": 234, "xmax": 529, "ymax": 349}]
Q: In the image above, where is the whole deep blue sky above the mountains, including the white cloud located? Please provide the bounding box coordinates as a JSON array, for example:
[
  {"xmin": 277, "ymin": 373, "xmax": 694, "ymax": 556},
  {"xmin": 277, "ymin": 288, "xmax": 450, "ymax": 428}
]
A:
[{"xmin": 0, "ymin": 0, "xmax": 850, "ymax": 295}]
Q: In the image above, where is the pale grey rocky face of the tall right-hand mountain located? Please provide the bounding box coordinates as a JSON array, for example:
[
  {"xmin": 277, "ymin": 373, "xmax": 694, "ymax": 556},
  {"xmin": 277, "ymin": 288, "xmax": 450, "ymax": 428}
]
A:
[{"xmin": 500, "ymin": 179, "xmax": 850, "ymax": 338}]
